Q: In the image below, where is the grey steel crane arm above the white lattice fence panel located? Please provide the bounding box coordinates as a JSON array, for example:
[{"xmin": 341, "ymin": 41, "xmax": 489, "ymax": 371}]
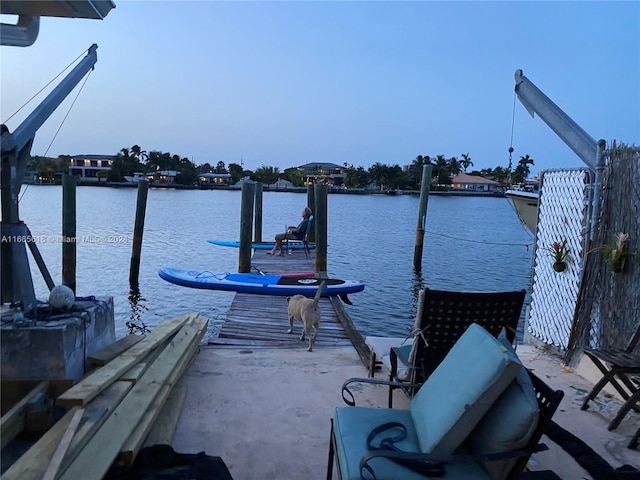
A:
[{"xmin": 515, "ymin": 70, "xmax": 598, "ymax": 171}]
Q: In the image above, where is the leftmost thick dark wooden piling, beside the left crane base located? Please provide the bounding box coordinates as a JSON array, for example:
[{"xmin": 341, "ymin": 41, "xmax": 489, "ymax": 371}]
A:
[{"xmin": 62, "ymin": 174, "xmax": 78, "ymax": 293}]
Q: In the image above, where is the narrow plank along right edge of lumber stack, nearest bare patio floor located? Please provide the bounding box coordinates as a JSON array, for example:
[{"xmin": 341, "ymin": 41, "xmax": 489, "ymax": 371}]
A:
[{"xmin": 119, "ymin": 317, "xmax": 209, "ymax": 466}]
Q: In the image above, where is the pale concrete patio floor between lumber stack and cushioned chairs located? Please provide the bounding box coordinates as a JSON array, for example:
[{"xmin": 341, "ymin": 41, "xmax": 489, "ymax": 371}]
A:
[{"xmin": 173, "ymin": 345, "xmax": 640, "ymax": 480}]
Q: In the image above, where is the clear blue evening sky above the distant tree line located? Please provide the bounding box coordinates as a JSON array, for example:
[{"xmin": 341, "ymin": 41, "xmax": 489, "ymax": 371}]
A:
[{"xmin": 0, "ymin": 0, "xmax": 640, "ymax": 175}]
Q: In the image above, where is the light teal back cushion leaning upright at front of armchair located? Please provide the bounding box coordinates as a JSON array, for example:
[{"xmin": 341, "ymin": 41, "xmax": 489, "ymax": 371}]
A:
[{"xmin": 411, "ymin": 324, "xmax": 523, "ymax": 454}]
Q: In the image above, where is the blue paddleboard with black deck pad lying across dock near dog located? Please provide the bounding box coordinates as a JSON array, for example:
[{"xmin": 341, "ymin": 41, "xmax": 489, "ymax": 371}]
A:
[{"xmin": 158, "ymin": 267, "xmax": 364, "ymax": 297}]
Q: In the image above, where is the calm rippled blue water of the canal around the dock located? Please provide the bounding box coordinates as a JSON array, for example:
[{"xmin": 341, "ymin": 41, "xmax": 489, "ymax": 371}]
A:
[{"xmin": 20, "ymin": 185, "xmax": 533, "ymax": 337}]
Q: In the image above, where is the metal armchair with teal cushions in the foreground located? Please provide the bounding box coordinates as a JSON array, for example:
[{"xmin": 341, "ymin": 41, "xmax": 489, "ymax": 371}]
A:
[{"xmin": 327, "ymin": 324, "xmax": 562, "ymax": 480}]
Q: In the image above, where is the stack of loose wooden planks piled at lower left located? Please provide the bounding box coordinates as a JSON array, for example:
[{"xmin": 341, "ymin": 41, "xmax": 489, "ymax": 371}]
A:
[{"xmin": 2, "ymin": 313, "xmax": 208, "ymax": 480}]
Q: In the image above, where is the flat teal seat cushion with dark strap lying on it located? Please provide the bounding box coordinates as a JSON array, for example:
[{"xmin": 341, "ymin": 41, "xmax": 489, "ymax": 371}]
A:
[{"xmin": 333, "ymin": 407, "xmax": 491, "ymax": 480}]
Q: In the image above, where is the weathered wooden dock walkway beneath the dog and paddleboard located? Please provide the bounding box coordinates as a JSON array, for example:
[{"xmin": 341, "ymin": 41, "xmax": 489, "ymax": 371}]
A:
[{"xmin": 209, "ymin": 250, "xmax": 369, "ymax": 361}]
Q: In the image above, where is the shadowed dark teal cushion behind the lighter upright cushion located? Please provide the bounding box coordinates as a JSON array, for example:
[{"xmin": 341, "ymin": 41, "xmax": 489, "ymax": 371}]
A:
[{"xmin": 467, "ymin": 331, "xmax": 540, "ymax": 480}]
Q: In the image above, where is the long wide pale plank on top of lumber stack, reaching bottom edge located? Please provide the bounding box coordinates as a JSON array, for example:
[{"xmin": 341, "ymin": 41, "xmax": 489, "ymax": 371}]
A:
[{"xmin": 60, "ymin": 316, "xmax": 204, "ymax": 480}]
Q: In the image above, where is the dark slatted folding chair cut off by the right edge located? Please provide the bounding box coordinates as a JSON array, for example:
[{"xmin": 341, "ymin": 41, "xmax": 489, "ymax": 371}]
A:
[{"xmin": 581, "ymin": 323, "xmax": 640, "ymax": 430}]
